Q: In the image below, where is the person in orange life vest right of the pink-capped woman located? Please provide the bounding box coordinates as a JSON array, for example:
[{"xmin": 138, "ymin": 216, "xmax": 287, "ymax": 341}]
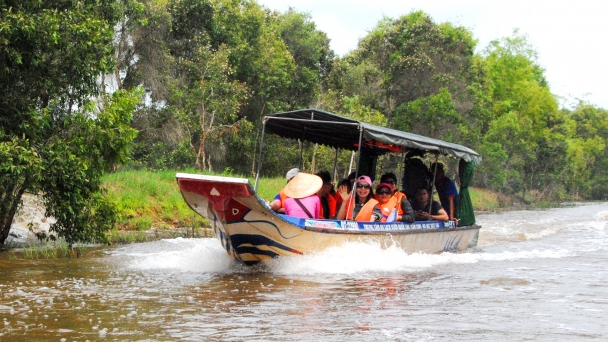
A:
[{"xmin": 376, "ymin": 183, "xmax": 416, "ymax": 223}]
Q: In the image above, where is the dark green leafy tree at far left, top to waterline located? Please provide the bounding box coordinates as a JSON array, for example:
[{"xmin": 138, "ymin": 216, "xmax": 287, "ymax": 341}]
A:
[{"xmin": 0, "ymin": 0, "xmax": 139, "ymax": 244}]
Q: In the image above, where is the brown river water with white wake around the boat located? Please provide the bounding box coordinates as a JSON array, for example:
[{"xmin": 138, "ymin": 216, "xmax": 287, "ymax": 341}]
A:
[{"xmin": 0, "ymin": 203, "xmax": 608, "ymax": 341}]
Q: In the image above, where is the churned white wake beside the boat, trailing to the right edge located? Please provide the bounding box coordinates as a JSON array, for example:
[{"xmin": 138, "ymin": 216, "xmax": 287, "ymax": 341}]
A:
[{"xmin": 109, "ymin": 203, "xmax": 608, "ymax": 275}]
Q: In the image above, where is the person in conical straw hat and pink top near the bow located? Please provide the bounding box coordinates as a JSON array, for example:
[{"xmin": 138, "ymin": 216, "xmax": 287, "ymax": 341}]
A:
[{"xmin": 283, "ymin": 172, "xmax": 323, "ymax": 219}]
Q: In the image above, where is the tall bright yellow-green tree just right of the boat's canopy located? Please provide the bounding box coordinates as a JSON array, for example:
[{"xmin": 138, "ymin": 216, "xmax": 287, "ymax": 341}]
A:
[{"xmin": 480, "ymin": 31, "xmax": 568, "ymax": 199}]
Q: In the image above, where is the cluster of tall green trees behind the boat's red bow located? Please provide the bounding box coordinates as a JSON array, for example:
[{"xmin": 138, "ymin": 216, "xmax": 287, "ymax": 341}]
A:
[{"xmin": 121, "ymin": 0, "xmax": 333, "ymax": 172}]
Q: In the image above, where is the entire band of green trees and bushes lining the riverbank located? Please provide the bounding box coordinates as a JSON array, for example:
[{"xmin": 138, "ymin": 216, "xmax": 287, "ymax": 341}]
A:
[{"xmin": 5, "ymin": 0, "xmax": 608, "ymax": 248}]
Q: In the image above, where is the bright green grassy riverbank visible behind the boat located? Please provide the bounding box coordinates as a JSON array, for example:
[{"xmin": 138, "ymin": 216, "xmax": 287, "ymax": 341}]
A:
[{"xmin": 103, "ymin": 170, "xmax": 508, "ymax": 231}]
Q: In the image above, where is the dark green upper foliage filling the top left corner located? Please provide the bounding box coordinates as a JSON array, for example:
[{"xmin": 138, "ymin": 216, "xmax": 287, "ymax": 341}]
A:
[{"xmin": 0, "ymin": 0, "xmax": 118, "ymax": 117}]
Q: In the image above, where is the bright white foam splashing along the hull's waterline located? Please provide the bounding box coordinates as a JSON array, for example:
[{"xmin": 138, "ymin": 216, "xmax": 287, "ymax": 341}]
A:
[{"xmin": 110, "ymin": 238, "xmax": 571, "ymax": 275}]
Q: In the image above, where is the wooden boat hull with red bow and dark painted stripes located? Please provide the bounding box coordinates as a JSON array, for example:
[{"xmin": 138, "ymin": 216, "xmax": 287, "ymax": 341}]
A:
[{"xmin": 176, "ymin": 173, "xmax": 481, "ymax": 265}]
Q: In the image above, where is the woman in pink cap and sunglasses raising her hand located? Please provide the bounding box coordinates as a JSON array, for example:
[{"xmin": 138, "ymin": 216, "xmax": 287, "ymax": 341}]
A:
[{"xmin": 337, "ymin": 176, "xmax": 382, "ymax": 222}]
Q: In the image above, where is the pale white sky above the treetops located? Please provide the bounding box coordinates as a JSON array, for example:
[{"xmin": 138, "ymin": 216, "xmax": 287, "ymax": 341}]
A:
[{"xmin": 257, "ymin": 0, "xmax": 608, "ymax": 109}]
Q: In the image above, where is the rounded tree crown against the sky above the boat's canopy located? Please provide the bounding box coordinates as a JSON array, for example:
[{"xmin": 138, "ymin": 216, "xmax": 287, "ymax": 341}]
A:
[{"xmin": 356, "ymin": 11, "xmax": 476, "ymax": 119}]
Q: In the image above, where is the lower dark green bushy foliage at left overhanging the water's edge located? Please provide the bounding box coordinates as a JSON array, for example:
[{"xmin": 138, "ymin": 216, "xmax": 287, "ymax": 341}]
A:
[{"xmin": 41, "ymin": 91, "xmax": 141, "ymax": 244}]
